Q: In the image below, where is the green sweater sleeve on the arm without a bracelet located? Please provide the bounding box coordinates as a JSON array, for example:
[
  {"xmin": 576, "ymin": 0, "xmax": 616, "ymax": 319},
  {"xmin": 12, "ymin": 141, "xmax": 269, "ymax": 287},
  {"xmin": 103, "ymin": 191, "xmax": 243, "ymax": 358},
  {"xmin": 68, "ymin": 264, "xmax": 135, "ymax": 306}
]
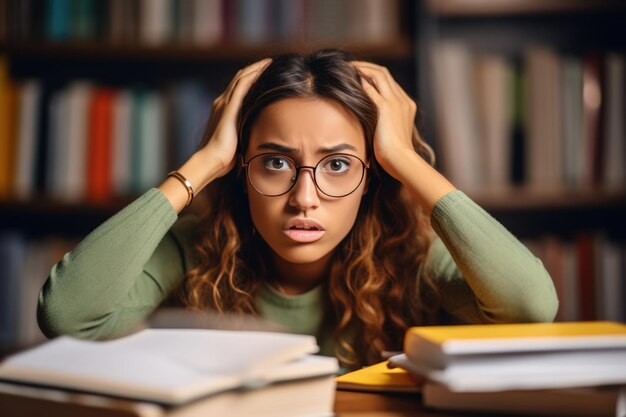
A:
[{"xmin": 426, "ymin": 190, "xmax": 558, "ymax": 323}]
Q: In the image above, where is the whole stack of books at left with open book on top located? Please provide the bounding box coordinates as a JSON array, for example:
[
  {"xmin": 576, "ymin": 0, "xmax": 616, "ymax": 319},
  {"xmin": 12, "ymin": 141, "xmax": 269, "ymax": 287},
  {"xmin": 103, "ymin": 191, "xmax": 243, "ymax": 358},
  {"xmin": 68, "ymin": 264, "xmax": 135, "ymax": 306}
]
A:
[{"xmin": 0, "ymin": 329, "xmax": 338, "ymax": 417}]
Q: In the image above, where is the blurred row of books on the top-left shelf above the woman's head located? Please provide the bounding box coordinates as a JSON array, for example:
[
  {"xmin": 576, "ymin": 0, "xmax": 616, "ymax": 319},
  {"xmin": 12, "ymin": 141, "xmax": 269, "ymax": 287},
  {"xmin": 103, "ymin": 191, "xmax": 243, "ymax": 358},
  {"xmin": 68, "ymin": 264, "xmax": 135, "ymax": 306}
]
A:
[{"xmin": 0, "ymin": 0, "xmax": 400, "ymax": 46}]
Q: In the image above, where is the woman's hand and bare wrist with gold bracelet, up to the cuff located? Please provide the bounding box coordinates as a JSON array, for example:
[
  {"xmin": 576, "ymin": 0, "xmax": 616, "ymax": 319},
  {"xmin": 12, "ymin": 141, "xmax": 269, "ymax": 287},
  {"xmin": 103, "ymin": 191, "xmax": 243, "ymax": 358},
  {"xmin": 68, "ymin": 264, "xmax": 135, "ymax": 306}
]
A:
[{"xmin": 159, "ymin": 58, "xmax": 271, "ymax": 212}]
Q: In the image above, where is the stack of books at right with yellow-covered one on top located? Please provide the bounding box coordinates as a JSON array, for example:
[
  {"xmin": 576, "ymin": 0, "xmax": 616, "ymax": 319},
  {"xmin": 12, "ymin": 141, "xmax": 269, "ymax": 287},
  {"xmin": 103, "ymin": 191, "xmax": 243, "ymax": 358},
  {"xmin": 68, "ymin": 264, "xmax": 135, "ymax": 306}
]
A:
[{"xmin": 390, "ymin": 322, "xmax": 626, "ymax": 416}]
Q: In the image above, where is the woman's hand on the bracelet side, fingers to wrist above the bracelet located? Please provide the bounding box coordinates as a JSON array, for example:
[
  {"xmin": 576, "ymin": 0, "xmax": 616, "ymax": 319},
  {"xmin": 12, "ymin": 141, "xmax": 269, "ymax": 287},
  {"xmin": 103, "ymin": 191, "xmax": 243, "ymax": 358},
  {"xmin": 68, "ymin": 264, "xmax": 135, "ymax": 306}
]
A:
[{"xmin": 199, "ymin": 58, "xmax": 271, "ymax": 180}]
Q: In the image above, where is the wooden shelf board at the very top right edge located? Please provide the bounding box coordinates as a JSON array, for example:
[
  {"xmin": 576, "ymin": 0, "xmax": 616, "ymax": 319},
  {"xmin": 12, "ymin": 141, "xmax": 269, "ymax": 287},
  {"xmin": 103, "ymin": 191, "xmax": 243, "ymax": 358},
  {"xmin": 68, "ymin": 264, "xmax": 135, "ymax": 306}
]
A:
[{"xmin": 427, "ymin": 0, "xmax": 626, "ymax": 17}]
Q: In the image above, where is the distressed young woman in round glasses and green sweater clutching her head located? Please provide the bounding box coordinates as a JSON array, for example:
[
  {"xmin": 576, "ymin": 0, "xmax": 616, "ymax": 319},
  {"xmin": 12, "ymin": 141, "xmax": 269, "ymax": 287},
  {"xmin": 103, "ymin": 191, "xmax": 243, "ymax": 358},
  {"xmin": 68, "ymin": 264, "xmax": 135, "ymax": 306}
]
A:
[{"xmin": 38, "ymin": 50, "xmax": 558, "ymax": 367}]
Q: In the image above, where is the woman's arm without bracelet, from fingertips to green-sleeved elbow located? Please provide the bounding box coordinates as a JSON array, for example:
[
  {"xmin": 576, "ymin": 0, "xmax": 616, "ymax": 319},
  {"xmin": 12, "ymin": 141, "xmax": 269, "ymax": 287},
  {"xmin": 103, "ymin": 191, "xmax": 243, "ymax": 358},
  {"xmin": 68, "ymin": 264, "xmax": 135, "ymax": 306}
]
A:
[{"xmin": 355, "ymin": 62, "xmax": 558, "ymax": 322}]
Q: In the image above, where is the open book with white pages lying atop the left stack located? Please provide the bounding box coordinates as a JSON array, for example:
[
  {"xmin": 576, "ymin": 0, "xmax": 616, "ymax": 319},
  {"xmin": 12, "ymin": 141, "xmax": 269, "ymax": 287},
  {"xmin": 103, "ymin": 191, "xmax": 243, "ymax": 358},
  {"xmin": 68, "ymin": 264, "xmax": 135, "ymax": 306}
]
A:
[{"xmin": 0, "ymin": 329, "xmax": 338, "ymax": 406}]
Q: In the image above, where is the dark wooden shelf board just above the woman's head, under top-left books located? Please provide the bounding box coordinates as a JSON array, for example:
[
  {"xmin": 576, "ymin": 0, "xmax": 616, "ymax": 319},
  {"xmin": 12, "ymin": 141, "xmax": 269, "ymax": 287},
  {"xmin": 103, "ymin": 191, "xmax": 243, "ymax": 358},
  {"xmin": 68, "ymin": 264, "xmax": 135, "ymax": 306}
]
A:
[{"xmin": 0, "ymin": 37, "xmax": 413, "ymax": 61}]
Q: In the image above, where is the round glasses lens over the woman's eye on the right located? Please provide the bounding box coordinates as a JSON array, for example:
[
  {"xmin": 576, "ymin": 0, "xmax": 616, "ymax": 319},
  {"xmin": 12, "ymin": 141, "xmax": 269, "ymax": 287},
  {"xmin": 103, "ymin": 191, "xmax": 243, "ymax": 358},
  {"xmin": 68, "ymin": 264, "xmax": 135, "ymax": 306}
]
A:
[{"xmin": 315, "ymin": 154, "xmax": 364, "ymax": 197}]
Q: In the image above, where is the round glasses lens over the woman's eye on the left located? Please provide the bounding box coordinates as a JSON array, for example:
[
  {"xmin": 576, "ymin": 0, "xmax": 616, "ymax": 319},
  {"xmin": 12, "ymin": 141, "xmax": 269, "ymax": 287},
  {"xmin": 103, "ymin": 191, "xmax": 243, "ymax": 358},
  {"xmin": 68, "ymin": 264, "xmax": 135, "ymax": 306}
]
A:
[{"xmin": 248, "ymin": 154, "xmax": 296, "ymax": 196}]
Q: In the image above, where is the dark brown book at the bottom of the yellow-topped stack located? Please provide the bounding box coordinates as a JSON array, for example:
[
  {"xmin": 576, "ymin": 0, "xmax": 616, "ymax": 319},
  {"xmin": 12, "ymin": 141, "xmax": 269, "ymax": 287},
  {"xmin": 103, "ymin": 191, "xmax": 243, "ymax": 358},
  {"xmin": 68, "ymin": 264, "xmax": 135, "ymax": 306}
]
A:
[{"xmin": 422, "ymin": 382, "xmax": 626, "ymax": 417}]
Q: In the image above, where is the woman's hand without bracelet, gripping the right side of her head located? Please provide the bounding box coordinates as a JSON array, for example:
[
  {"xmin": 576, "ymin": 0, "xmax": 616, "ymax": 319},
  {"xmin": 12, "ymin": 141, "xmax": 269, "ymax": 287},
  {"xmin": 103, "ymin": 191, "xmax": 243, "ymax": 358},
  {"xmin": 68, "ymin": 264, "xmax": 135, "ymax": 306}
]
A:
[{"xmin": 353, "ymin": 61, "xmax": 417, "ymax": 180}]
